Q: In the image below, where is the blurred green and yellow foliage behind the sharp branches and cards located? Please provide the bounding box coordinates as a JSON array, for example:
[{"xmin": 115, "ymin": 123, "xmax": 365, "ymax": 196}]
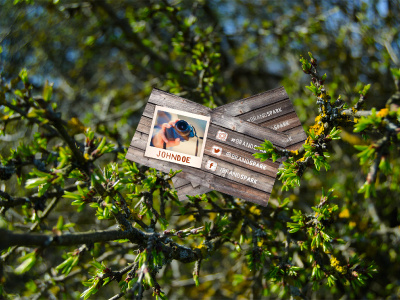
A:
[{"xmin": 0, "ymin": 0, "xmax": 400, "ymax": 299}]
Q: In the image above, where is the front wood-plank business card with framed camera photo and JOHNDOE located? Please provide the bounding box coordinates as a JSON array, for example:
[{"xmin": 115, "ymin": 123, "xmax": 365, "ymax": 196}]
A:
[{"xmin": 126, "ymin": 89, "xmax": 304, "ymax": 205}]
